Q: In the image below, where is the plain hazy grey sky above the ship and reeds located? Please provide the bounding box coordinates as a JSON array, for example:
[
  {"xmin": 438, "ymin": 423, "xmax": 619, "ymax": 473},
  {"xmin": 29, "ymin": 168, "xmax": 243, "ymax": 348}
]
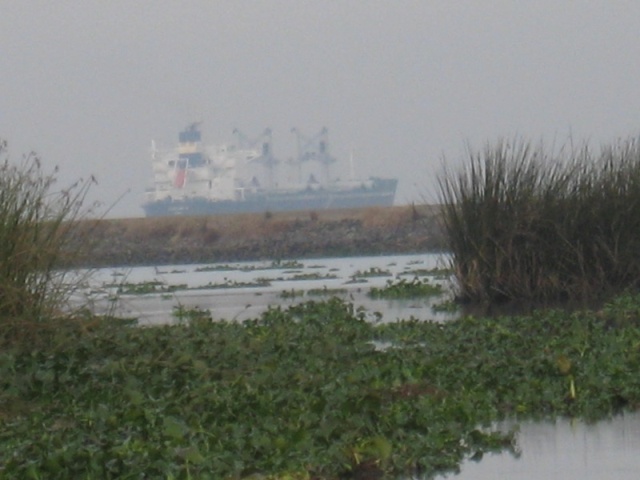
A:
[{"xmin": 0, "ymin": 0, "xmax": 640, "ymax": 216}]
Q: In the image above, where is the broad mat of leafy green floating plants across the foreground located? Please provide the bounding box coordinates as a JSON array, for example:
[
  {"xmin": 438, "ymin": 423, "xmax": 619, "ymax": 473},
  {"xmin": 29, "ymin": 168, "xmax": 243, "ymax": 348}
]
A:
[{"xmin": 0, "ymin": 296, "xmax": 640, "ymax": 480}]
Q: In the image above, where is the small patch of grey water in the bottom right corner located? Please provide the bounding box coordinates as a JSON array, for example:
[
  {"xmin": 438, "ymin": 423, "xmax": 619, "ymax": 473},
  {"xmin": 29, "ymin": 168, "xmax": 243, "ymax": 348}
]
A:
[{"xmin": 436, "ymin": 412, "xmax": 640, "ymax": 480}]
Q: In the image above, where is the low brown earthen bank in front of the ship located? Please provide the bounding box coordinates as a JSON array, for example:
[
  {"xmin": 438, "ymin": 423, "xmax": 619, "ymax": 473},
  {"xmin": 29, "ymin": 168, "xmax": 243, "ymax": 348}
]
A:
[{"xmin": 78, "ymin": 206, "xmax": 443, "ymax": 266}]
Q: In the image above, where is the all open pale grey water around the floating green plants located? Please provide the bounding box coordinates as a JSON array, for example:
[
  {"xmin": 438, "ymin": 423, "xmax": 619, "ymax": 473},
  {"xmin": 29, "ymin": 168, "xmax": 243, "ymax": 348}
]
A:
[{"xmin": 78, "ymin": 254, "xmax": 640, "ymax": 480}]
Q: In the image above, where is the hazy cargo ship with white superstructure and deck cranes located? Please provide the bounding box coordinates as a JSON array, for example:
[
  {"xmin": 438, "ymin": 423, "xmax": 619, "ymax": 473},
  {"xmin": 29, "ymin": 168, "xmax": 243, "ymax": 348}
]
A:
[{"xmin": 142, "ymin": 123, "xmax": 398, "ymax": 217}]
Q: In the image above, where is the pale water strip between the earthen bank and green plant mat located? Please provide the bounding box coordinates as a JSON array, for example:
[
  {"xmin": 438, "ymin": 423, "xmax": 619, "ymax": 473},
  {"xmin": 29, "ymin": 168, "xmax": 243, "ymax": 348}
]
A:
[{"xmin": 80, "ymin": 254, "xmax": 451, "ymax": 324}]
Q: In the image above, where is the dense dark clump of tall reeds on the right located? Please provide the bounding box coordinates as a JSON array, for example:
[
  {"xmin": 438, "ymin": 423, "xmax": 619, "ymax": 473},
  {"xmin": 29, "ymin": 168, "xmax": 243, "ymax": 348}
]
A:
[{"xmin": 438, "ymin": 139, "xmax": 640, "ymax": 303}]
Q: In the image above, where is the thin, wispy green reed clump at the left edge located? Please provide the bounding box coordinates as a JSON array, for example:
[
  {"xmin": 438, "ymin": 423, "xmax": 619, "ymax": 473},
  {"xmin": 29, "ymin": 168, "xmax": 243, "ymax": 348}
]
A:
[{"xmin": 0, "ymin": 142, "xmax": 92, "ymax": 344}]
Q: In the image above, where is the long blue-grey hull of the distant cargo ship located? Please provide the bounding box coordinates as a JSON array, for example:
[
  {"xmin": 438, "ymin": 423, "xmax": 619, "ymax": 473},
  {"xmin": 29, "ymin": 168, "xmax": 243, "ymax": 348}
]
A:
[{"xmin": 142, "ymin": 179, "xmax": 398, "ymax": 217}]
